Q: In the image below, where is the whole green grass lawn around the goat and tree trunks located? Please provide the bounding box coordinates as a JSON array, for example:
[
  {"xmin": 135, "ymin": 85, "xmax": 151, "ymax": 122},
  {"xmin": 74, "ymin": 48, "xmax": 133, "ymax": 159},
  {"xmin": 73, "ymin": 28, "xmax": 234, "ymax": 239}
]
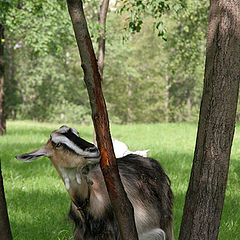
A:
[{"xmin": 0, "ymin": 121, "xmax": 240, "ymax": 240}]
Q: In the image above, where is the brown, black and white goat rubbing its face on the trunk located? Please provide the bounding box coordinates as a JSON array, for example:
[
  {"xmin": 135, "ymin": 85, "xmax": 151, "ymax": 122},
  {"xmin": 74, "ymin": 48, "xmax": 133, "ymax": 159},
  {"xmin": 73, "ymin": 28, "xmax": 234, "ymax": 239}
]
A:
[{"xmin": 16, "ymin": 126, "xmax": 174, "ymax": 240}]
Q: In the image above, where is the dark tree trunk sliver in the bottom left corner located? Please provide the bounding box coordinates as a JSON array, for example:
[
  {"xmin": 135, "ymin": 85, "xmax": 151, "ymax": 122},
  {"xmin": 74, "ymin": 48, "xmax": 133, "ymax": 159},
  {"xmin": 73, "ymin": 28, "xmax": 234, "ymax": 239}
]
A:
[{"xmin": 0, "ymin": 160, "xmax": 12, "ymax": 240}]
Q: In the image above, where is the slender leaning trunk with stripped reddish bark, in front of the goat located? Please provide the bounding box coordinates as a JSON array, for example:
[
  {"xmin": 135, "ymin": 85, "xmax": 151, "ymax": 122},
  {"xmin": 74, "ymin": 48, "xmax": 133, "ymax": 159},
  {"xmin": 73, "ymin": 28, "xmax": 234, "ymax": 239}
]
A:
[{"xmin": 67, "ymin": 0, "xmax": 138, "ymax": 240}]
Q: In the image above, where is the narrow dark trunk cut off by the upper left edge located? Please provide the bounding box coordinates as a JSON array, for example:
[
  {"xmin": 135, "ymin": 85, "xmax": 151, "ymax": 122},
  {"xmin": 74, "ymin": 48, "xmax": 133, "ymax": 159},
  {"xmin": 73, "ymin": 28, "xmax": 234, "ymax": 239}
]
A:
[{"xmin": 0, "ymin": 23, "xmax": 6, "ymax": 135}]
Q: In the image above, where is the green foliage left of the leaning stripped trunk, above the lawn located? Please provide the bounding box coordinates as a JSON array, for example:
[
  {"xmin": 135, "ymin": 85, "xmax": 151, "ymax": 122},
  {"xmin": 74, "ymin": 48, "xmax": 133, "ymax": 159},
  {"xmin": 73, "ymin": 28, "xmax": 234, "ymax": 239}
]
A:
[{"xmin": 3, "ymin": 1, "xmax": 90, "ymax": 122}]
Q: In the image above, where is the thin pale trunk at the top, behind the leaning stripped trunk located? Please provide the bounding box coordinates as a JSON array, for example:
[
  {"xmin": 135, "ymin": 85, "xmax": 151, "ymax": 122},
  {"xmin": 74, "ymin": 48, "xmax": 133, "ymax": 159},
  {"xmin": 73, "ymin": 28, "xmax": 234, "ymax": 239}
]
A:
[{"xmin": 98, "ymin": 0, "xmax": 109, "ymax": 78}]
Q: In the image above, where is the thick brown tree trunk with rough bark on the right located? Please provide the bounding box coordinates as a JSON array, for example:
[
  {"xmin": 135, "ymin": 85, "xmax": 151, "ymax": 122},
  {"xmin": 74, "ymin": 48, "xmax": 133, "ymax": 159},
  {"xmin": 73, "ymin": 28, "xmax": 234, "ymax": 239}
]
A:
[{"xmin": 179, "ymin": 0, "xmax": 240, "ymax": 240}]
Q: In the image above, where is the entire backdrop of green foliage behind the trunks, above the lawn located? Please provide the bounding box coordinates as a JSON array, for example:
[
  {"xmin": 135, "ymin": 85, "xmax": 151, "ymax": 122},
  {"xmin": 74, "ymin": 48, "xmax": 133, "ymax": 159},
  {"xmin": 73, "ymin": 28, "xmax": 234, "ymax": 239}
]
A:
[{"xmin": 2, "ymin": 0, "xmax": 208, "ymax": 123}]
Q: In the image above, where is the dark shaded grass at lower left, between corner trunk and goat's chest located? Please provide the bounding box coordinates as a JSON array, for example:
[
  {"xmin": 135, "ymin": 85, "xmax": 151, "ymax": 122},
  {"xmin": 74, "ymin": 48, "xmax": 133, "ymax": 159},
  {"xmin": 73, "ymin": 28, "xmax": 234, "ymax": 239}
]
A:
[{"xmin": 8, "ymin": 189, "xmax": 73, "ymax": 240}]
